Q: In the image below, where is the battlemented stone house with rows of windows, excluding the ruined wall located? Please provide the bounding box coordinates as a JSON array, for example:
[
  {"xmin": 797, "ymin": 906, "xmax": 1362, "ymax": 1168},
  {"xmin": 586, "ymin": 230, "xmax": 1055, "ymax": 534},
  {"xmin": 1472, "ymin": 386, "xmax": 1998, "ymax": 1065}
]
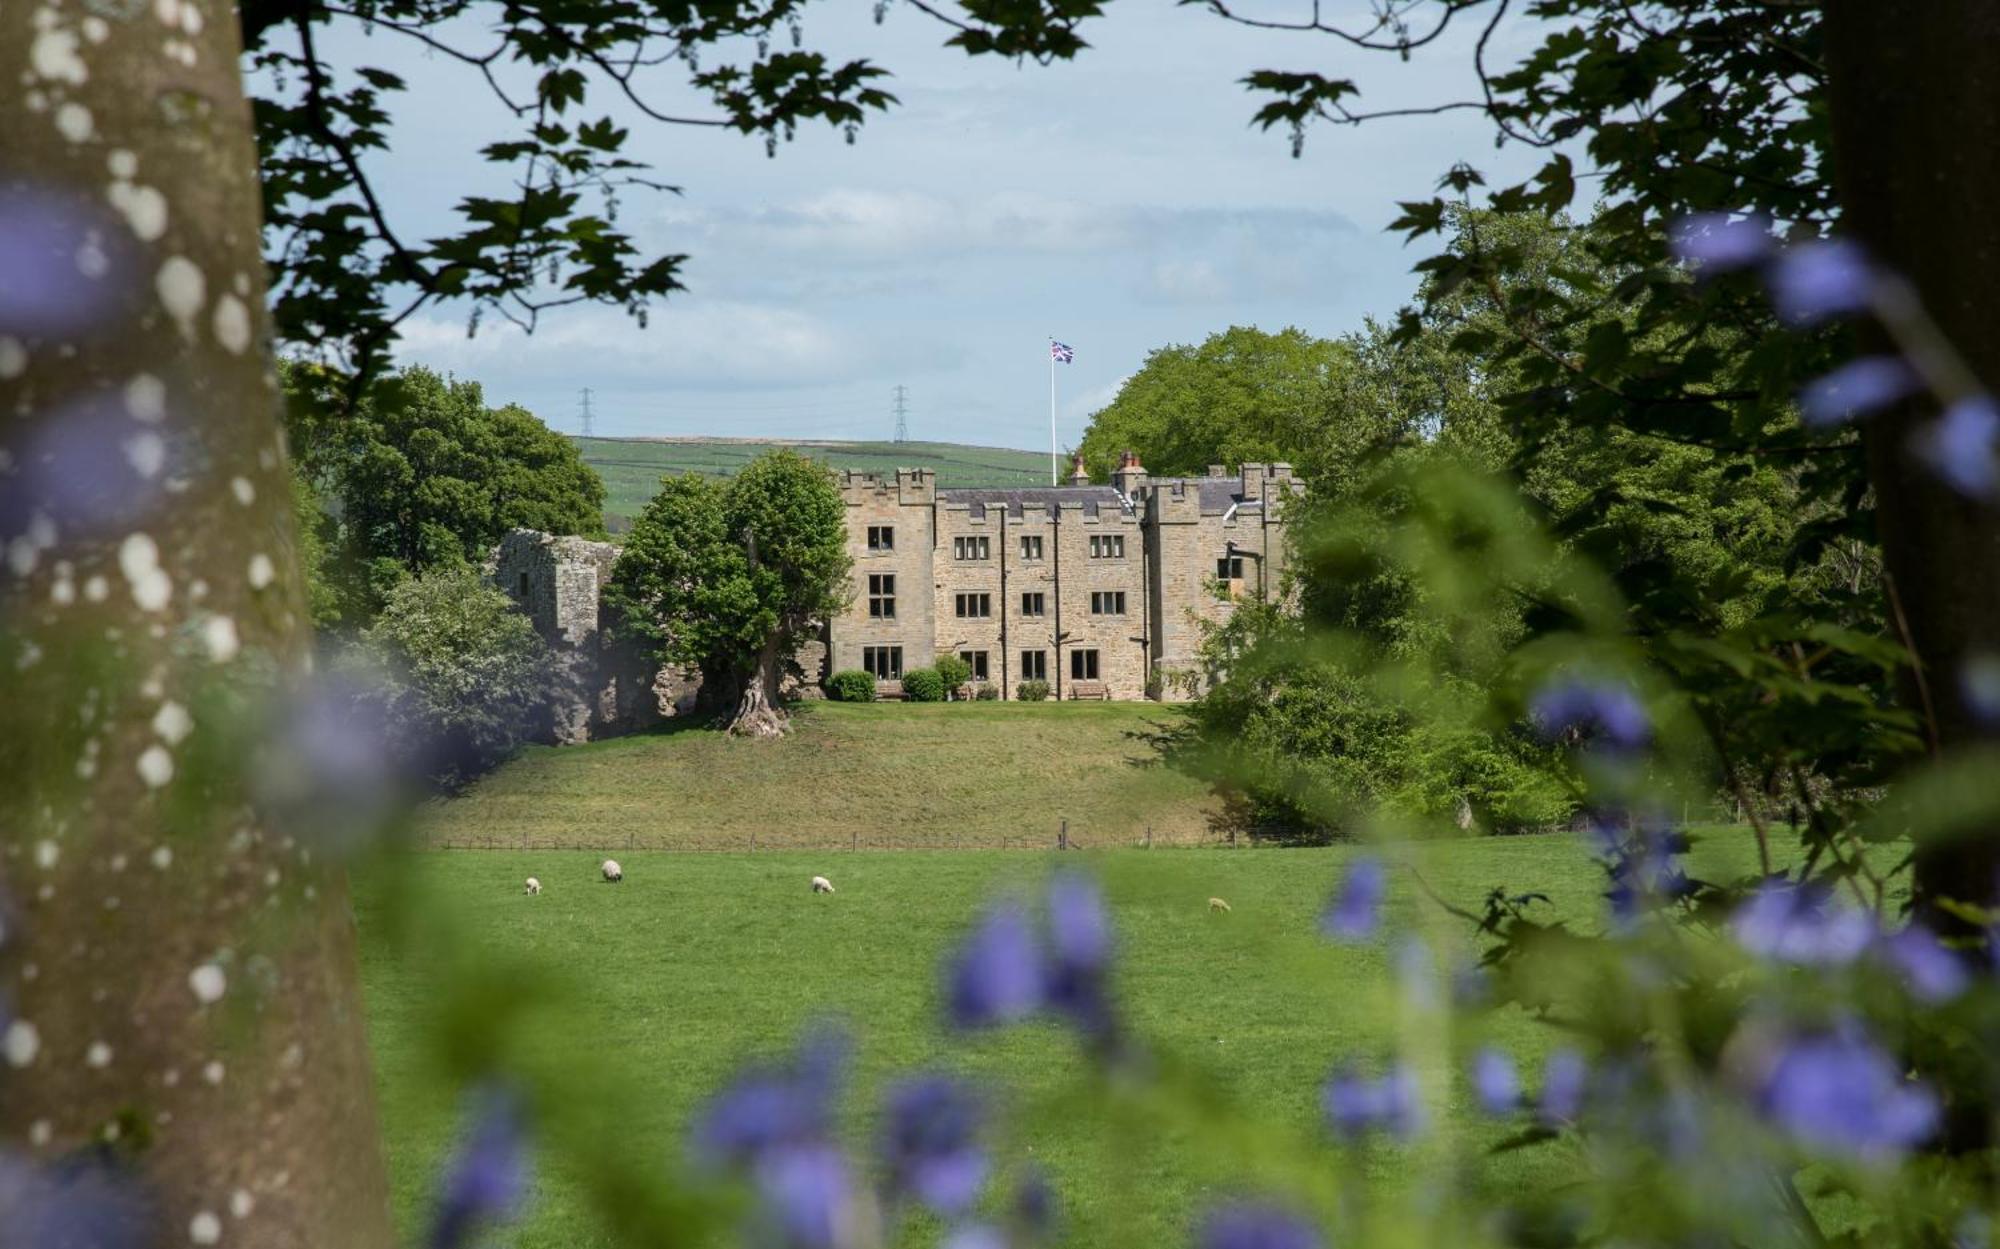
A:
[{"xmin": 828, "ymin": 454, "xmax": 1302, "ymax": 699}]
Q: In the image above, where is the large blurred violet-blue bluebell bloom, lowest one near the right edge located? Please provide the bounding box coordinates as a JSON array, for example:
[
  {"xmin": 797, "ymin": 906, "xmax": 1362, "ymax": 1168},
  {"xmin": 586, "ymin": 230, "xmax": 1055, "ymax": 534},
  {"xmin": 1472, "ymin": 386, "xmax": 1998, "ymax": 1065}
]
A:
[{"xmin": 1758, "ymin": 1023, "xmax": 1938, "ymax": 1163}]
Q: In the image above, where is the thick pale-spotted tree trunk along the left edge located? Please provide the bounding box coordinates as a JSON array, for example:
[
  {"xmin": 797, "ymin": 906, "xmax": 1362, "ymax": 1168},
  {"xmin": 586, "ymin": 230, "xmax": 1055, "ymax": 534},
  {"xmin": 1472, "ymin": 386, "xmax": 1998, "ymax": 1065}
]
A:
[{"xmin": 0, "ymin": 0, "xmax": 392, "ymax": 1249}]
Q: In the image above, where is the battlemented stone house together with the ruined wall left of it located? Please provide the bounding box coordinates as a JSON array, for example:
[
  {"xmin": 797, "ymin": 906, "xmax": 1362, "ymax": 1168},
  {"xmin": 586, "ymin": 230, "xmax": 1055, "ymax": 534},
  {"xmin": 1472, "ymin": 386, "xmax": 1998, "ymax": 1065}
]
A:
[{"xmin": 490, "ymin": 452, "xmax": 1304, "ymax": 741}]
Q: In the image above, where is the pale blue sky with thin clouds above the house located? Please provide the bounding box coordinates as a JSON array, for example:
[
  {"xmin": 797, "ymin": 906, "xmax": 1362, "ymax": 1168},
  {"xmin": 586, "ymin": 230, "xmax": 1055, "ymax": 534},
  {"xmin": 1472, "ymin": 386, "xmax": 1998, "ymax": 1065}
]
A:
[{"xmin": 328, "ymin": 0, "xmax": 1536, "ymax": 448}]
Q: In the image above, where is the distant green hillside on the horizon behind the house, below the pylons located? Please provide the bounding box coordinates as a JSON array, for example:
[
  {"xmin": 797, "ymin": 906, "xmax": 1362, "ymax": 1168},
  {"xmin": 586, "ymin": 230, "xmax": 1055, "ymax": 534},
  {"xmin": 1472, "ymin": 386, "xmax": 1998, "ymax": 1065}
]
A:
[{"xmin": 576, "ymin": 438, "xmax": 1048, "ymax": 532}]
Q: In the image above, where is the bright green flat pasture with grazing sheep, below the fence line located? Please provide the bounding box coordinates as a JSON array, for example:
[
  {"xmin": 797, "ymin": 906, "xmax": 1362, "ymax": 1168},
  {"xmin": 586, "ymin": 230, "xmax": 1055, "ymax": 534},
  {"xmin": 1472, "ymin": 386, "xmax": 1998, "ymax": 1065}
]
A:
[{"xmin": 356, "ymin": 824, "xmax": 1752, "ymax": 1249}]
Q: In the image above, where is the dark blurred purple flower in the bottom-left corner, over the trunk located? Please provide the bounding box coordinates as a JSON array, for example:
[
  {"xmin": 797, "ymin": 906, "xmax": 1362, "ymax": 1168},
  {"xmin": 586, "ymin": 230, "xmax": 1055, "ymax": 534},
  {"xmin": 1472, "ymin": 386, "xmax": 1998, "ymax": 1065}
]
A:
[{"xmin": 0, "ymin": 1149, "xmax": 158, "ymax": 1249}]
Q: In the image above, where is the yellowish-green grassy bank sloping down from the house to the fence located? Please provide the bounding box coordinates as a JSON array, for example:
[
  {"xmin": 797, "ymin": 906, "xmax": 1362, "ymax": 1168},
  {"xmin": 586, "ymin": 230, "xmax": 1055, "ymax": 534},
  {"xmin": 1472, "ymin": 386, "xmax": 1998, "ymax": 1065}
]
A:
[{"xmin": 422, "ymin": 703, "xmax": 1216, "ymax": 849}]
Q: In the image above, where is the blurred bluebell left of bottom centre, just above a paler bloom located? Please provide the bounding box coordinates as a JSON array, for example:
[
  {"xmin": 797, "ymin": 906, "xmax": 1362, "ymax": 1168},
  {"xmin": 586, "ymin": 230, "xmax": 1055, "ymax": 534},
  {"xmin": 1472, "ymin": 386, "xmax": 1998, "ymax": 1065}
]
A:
[{"xmin": 692, "ymin": 1029, "xmax": 844, "ymax": 1167}]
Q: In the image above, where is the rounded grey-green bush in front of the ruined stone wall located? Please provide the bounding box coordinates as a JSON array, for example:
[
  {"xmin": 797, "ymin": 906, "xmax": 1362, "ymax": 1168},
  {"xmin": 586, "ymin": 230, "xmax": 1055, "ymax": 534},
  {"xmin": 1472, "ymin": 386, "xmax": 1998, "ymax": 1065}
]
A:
[{"xmin": 350, "ymin": 568, "xmax": 556, "ymax": 785}]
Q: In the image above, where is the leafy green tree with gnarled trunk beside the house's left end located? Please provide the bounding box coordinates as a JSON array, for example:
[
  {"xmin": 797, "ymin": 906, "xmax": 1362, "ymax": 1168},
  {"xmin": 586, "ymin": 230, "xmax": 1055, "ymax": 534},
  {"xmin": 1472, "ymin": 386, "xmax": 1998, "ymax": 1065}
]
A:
[{"xmin": 604, "ymin": 448, "xmax": 852, "ymax": 737}]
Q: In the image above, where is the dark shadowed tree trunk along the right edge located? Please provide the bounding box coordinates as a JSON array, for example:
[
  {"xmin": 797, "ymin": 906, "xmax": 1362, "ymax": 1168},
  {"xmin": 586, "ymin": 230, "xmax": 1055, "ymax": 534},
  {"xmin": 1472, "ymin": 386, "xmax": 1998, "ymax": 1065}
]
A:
[{"xmin": 1826, "ymin": 0, "xmax": 2000, "ymax": 929}]
